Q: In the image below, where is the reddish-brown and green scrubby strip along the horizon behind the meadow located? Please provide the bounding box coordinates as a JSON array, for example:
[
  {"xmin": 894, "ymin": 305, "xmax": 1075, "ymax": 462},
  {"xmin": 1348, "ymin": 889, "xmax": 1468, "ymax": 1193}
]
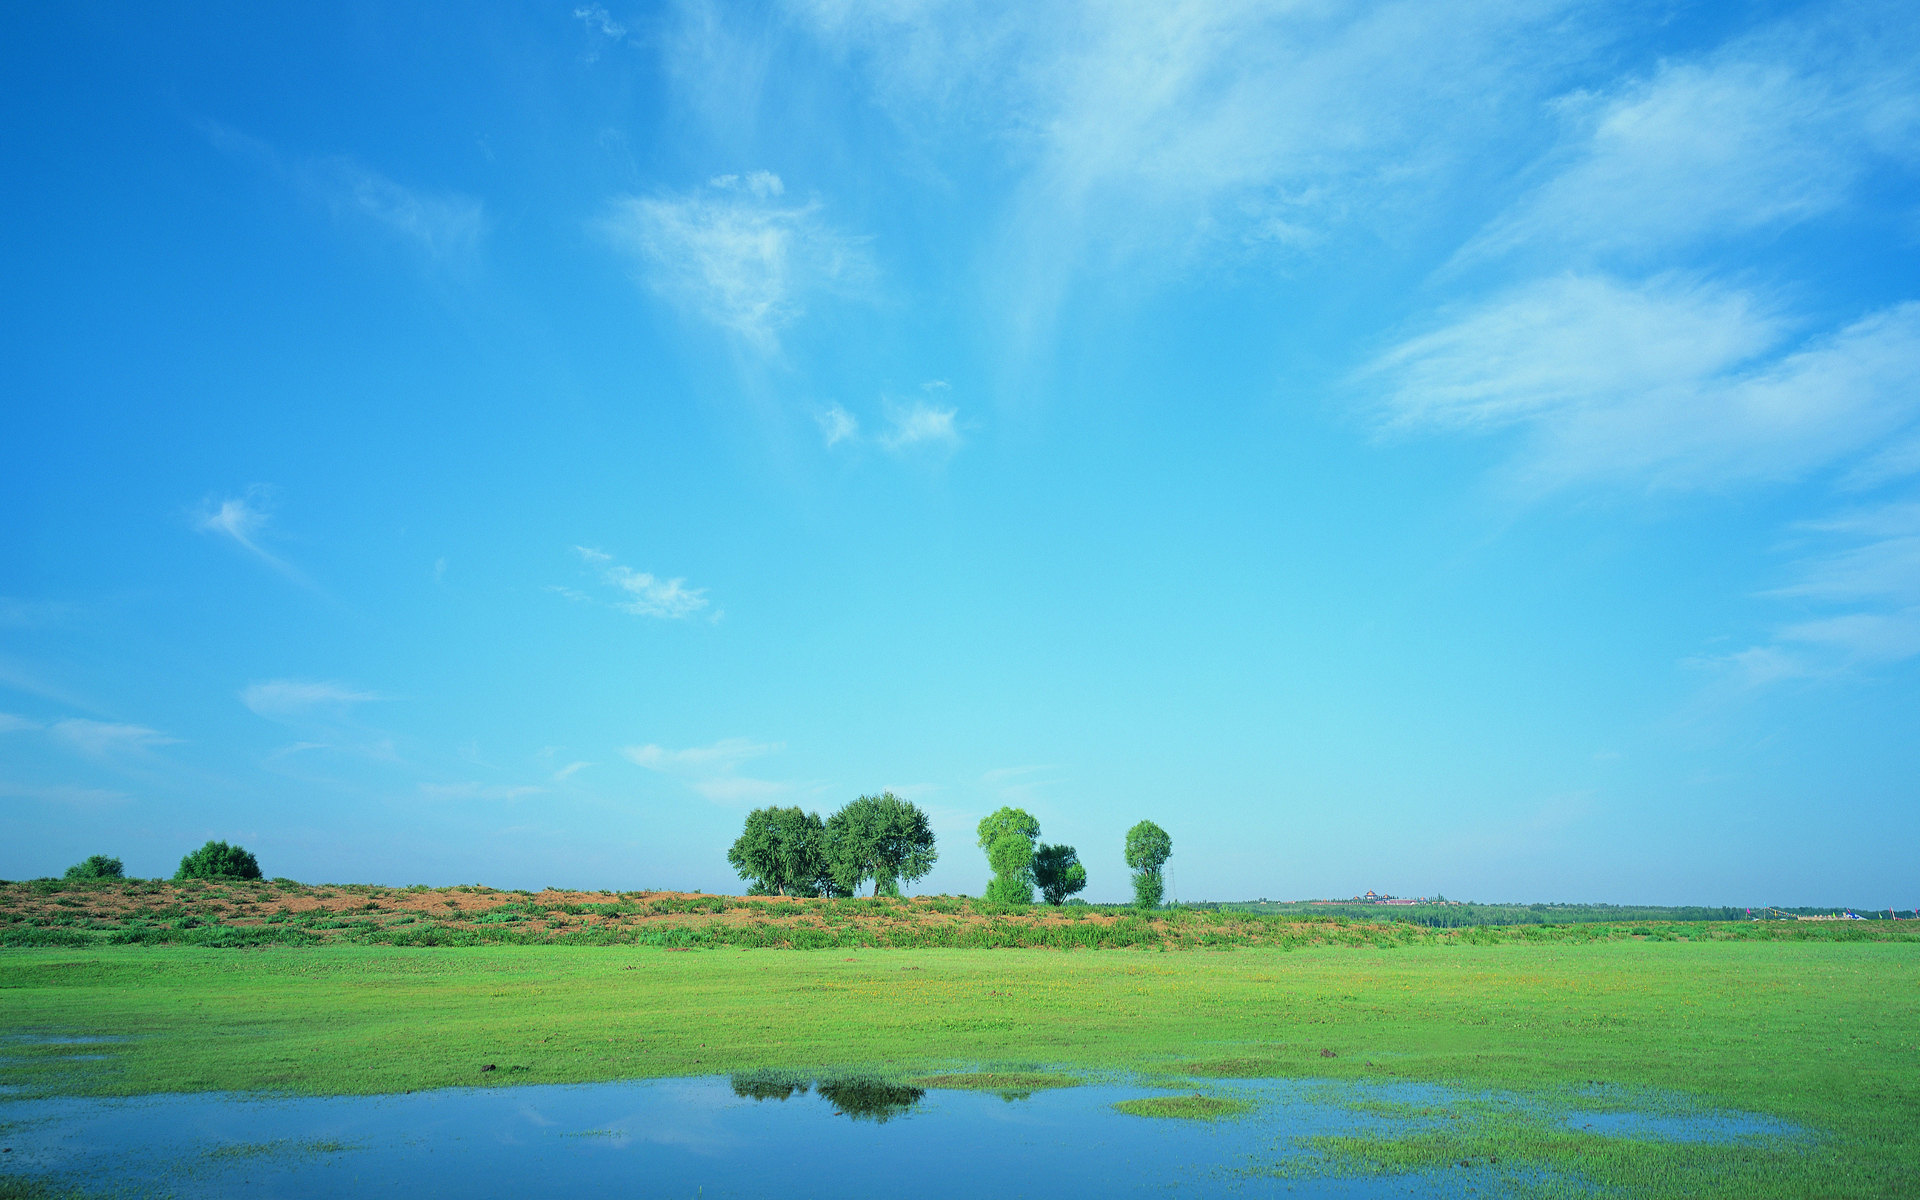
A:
[{"xmin": 0, "ymin": 879, "xmax": 1920, "ymax": 950}]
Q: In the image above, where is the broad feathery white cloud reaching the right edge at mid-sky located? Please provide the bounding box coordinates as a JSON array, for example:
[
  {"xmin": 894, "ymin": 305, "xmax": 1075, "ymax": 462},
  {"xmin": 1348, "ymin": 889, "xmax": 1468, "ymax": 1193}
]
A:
[{"xmin": 1361, "ymin": 275, "xmax": 1920, "ymax": 490}]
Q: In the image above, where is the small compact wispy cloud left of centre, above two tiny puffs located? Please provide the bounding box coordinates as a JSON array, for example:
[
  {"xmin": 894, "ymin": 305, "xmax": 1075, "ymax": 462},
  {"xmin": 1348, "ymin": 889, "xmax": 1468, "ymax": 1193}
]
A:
[{"xmin": 601, "ymin": 171, "xmax": 876, "ymax": 353}]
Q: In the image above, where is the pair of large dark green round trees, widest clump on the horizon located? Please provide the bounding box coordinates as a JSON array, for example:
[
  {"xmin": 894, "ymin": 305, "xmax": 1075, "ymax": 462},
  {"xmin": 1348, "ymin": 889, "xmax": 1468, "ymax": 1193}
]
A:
[{"xmin": 726, "ymin": 791, "xmax": 939, "ymax": 897}]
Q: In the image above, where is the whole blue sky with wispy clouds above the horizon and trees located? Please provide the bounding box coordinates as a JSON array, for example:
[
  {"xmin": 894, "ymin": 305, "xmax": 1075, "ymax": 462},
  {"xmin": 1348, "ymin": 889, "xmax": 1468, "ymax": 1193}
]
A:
[{"xmin": 0, "ymin": 0, "xmax": 1920, "ymax": 906}]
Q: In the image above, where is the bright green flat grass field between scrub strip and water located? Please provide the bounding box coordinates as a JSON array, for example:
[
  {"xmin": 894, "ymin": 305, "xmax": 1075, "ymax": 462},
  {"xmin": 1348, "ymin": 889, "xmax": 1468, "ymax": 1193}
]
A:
[{"xmin": 0, "ymin": 937, "xmax": 1920, "ymax": 1196}]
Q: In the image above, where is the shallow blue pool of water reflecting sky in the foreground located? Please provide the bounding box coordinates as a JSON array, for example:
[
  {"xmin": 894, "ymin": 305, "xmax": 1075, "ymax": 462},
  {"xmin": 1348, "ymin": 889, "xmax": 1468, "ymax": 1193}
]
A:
[{"xmin": 0, "ymin": 1071, "xmax": 1791, "ymax": 1200}]
